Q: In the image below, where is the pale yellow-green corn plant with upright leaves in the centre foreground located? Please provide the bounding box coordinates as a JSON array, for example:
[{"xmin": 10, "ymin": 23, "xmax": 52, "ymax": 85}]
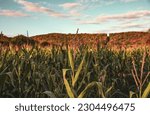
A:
[{"xmin": 63, "ymin": 50, "xmax": 113, "ymax": 98}]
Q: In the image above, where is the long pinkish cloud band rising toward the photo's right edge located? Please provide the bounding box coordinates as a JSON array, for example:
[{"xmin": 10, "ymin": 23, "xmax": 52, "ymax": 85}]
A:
[{"xmin": 79, "ymin": 10, "xmax": 150, "ymax": 24}]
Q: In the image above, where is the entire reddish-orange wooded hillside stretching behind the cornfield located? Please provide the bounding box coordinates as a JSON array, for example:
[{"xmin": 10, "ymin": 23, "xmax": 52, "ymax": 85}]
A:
[{"xmin": 0, "ymin": 32, "xmax": 150, "ymax": 47}]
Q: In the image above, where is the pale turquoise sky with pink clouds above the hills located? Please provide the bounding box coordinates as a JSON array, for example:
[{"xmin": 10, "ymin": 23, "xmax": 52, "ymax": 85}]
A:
[{"xmin": 0, "ymin": 0, "xmax": 150, "ymax": 36}]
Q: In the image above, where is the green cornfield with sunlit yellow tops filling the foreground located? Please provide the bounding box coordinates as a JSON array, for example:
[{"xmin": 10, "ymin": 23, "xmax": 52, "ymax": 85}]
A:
[{"xmin": 0, "ymin": 45, "xmax": 150, "ymax": 98}]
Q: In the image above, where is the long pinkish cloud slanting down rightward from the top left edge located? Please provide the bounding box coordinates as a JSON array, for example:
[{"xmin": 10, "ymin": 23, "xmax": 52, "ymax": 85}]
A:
[{"xmin": 15, "ymin": 0, "xmax": 67, "ymax": 17}]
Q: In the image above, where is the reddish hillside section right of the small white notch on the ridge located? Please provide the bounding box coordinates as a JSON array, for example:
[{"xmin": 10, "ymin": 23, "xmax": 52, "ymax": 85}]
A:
[{"xmin": 109, "ymin": 32, "xmax": 150, "ymax": 47}]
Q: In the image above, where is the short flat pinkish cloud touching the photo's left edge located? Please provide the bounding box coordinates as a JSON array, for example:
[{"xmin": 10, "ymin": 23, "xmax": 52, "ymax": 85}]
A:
[{"xmin": 0, "ymin": 10, "xmax": 29, "ymax": 17}]
